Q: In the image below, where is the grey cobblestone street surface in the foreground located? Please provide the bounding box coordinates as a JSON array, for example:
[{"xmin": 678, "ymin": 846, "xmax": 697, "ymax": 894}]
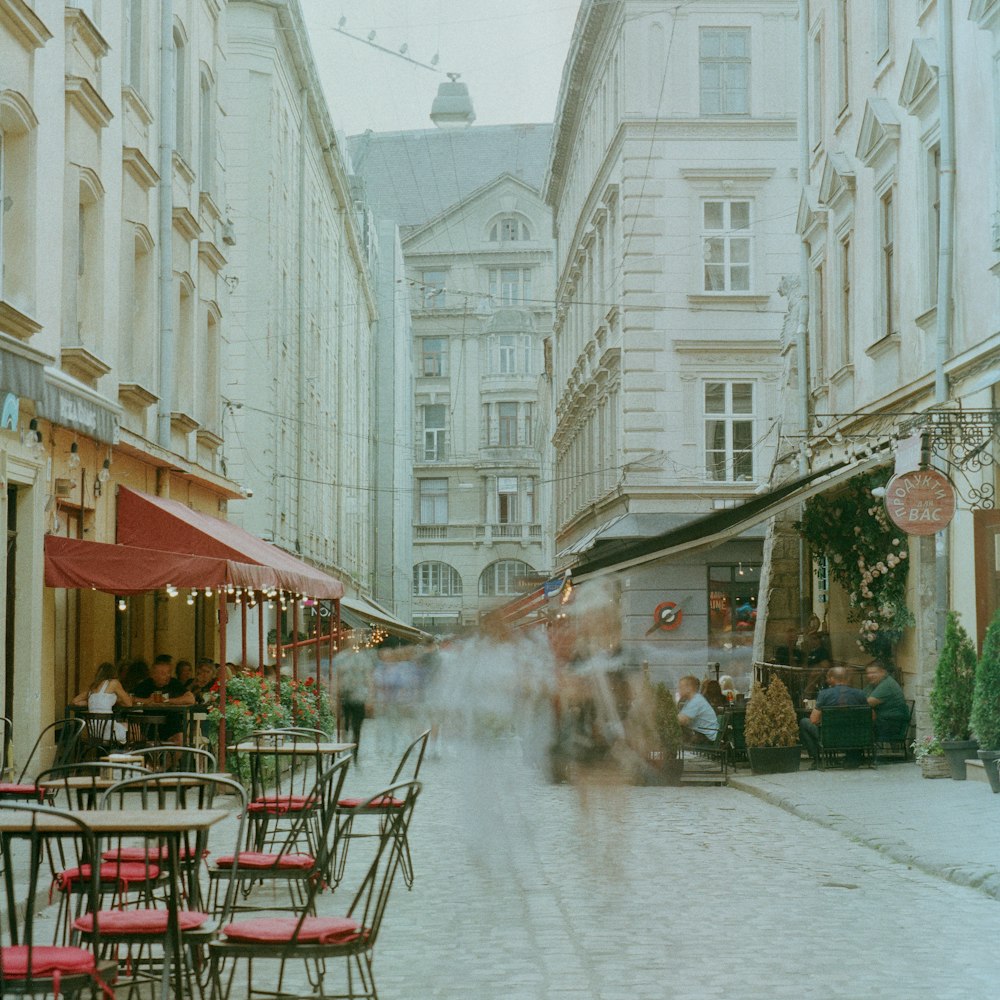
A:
[{"xmin": 330, "ymin": 726, "xmax": 1000, "ymax": 1000}]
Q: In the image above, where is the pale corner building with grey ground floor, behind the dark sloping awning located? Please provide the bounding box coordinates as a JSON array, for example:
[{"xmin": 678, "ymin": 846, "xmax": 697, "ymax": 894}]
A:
[{"xmin": 544, "ymin": 0, "xmax": 798, "ymax": 676}]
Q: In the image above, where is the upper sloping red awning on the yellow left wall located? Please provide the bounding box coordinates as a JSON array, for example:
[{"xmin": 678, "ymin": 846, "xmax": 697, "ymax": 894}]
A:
[{"xmin": 109, "ymin": 486, "xmax": 344, "ymax": 600}]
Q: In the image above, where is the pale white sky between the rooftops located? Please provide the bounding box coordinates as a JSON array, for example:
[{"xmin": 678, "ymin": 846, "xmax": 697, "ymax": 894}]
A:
[{"xmin": 300, "ymin": 0, "xmax": 580, "ymax": 135}]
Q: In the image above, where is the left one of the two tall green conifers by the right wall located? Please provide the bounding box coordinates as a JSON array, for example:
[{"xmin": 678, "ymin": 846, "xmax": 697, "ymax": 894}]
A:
[{"xmin": 930, "ymin": 611, "xmax": 978, "ymax": 781}]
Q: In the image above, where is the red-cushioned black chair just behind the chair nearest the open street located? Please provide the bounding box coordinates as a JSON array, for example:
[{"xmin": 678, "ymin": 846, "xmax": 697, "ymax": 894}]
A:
[{"xmin": 208, "ymin": 757, "xmax": 351, "ymax": 913}]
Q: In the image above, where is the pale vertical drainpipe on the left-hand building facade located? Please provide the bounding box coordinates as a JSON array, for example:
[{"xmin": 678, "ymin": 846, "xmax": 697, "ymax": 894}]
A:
[{"xmin": 156, "ymin": 0, "xmax": 177, "ymax": 451}]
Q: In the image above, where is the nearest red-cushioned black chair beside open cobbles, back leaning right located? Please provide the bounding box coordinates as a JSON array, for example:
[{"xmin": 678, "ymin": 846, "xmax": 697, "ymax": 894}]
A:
[{"xmin": 208, "ymin": 781, "xmax": 420, "ymax": 1000}]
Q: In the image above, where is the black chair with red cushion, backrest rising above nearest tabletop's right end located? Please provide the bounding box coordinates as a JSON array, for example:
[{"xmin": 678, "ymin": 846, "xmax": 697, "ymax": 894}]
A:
[{"xmin": 73, "ymin": 772, "xmax": 246, "ymax": 996}]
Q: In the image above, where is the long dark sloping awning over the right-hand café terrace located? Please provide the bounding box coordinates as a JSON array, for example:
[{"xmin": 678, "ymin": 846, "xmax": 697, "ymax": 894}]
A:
[{"xmin": 573, "ymin": 455, "xmax": 889, "ymax": 583}]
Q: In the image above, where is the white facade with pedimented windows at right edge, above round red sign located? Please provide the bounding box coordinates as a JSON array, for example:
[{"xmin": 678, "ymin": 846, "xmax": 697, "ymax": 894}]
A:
[{"xmin": 784, "ymin": 0, "xmax": 1000, "ymax": 721}]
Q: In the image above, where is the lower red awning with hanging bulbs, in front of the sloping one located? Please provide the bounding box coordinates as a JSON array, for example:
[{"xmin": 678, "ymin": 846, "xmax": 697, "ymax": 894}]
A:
[{"xmin": 45, "ymin": 535, "xmax": 274, "ymax": 594}]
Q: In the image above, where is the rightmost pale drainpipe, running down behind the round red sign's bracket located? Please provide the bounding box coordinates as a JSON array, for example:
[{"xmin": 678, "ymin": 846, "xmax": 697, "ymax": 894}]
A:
[{"xmin": 934, "ymin": 3, "xmax": 956, "ymax": 649}]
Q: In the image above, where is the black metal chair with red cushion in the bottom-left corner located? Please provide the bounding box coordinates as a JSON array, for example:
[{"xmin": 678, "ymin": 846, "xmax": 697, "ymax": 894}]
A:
[{"xmin": 0, "ymin": 803, "xmax": 116, "ymax": 1000}]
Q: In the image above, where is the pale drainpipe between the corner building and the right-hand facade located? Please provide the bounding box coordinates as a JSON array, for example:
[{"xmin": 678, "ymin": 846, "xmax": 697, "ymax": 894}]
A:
[{"xmin": 795, "ymin": 0, "xmax": 811, "ymax": 631}]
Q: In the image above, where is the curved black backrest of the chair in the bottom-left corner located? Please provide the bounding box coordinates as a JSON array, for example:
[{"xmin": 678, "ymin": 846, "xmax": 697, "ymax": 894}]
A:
[{"xmin": 0, "ymin": 802, "xmax": 106, "ymax": 980}]
